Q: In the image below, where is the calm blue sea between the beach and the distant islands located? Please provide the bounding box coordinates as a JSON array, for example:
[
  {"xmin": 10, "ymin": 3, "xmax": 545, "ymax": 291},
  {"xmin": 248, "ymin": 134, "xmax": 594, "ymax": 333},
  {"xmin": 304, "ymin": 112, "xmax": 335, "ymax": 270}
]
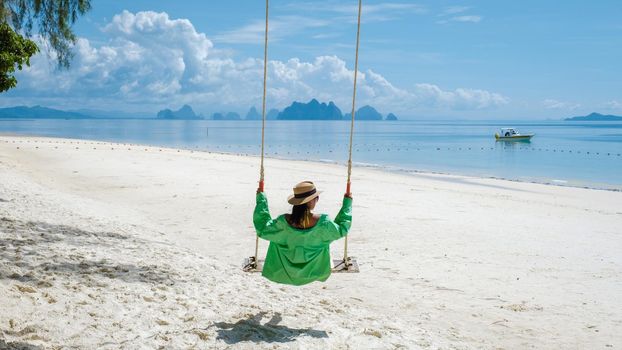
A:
[{"xmin": 0, "ymin": 119, "xmax": 622, "ymax": 190}]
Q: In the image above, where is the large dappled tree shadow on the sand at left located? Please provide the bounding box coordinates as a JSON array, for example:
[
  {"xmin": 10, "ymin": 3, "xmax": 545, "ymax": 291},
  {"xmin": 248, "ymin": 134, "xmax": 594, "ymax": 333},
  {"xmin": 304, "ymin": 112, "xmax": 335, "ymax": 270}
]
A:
[{"xmin": 0, "ymin": 218, "xmax": 175, "ymax": 287}]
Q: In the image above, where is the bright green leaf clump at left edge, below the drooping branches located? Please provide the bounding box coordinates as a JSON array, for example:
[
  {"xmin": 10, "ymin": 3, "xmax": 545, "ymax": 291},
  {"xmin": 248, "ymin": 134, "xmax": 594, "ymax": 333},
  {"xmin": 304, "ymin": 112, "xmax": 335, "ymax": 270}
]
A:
[{"xmin": 0, "ymin": 22, "xmax": 39, "ymax": 92}]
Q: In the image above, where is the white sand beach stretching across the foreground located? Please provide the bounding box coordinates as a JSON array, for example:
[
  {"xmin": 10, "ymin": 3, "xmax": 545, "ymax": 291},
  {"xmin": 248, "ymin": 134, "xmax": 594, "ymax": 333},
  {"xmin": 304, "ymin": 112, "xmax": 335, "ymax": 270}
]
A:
[{"xmin": 0, "ymin": 135, "xmax": 622, "ymax": 349}]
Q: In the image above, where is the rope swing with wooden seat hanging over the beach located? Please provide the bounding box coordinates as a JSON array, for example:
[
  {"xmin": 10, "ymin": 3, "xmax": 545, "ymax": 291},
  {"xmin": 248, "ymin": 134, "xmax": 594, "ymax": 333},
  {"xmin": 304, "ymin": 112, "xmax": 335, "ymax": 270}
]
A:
[{"xmin": 244, "ymin": 0, "xmax": 362, "ymax": 272}]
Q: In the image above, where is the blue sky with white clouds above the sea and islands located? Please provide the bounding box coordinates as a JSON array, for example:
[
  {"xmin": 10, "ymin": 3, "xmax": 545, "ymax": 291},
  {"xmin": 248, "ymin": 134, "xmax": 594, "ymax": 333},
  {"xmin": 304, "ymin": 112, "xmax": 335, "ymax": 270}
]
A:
[{"xmin": 0, "ymin": 0, "xmax": 622, "ymax": 119}]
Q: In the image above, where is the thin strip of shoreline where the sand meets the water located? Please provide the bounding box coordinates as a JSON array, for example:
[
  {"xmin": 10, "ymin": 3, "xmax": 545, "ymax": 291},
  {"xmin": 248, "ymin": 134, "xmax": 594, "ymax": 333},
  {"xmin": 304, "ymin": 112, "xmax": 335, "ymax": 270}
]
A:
[{"xmin": 0, "ymin": 132, "xmax": 622, "ymax": 192}]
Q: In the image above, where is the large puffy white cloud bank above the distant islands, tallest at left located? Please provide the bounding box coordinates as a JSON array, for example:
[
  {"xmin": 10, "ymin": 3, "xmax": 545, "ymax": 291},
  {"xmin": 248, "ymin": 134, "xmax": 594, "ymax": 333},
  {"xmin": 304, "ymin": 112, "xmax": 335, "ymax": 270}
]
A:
[{"xmin": 5, "ymin": 11, "xmax": 509, "ymax": 113}]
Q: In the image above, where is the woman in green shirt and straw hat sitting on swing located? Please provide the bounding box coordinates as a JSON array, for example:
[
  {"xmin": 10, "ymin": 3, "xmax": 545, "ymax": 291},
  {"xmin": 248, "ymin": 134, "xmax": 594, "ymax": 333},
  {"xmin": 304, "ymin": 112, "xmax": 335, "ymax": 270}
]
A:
[{"xmin": 253, "ymin": 181, "xmax": 352, "ymax": 286}]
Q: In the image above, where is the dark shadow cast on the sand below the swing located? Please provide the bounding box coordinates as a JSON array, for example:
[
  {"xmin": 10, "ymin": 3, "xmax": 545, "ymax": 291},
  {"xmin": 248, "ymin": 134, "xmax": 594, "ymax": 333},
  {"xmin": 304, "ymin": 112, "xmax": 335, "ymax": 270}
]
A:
[{"xmin": 210, "ymin": 312, "xmax": 328, "ymax": 344}]
